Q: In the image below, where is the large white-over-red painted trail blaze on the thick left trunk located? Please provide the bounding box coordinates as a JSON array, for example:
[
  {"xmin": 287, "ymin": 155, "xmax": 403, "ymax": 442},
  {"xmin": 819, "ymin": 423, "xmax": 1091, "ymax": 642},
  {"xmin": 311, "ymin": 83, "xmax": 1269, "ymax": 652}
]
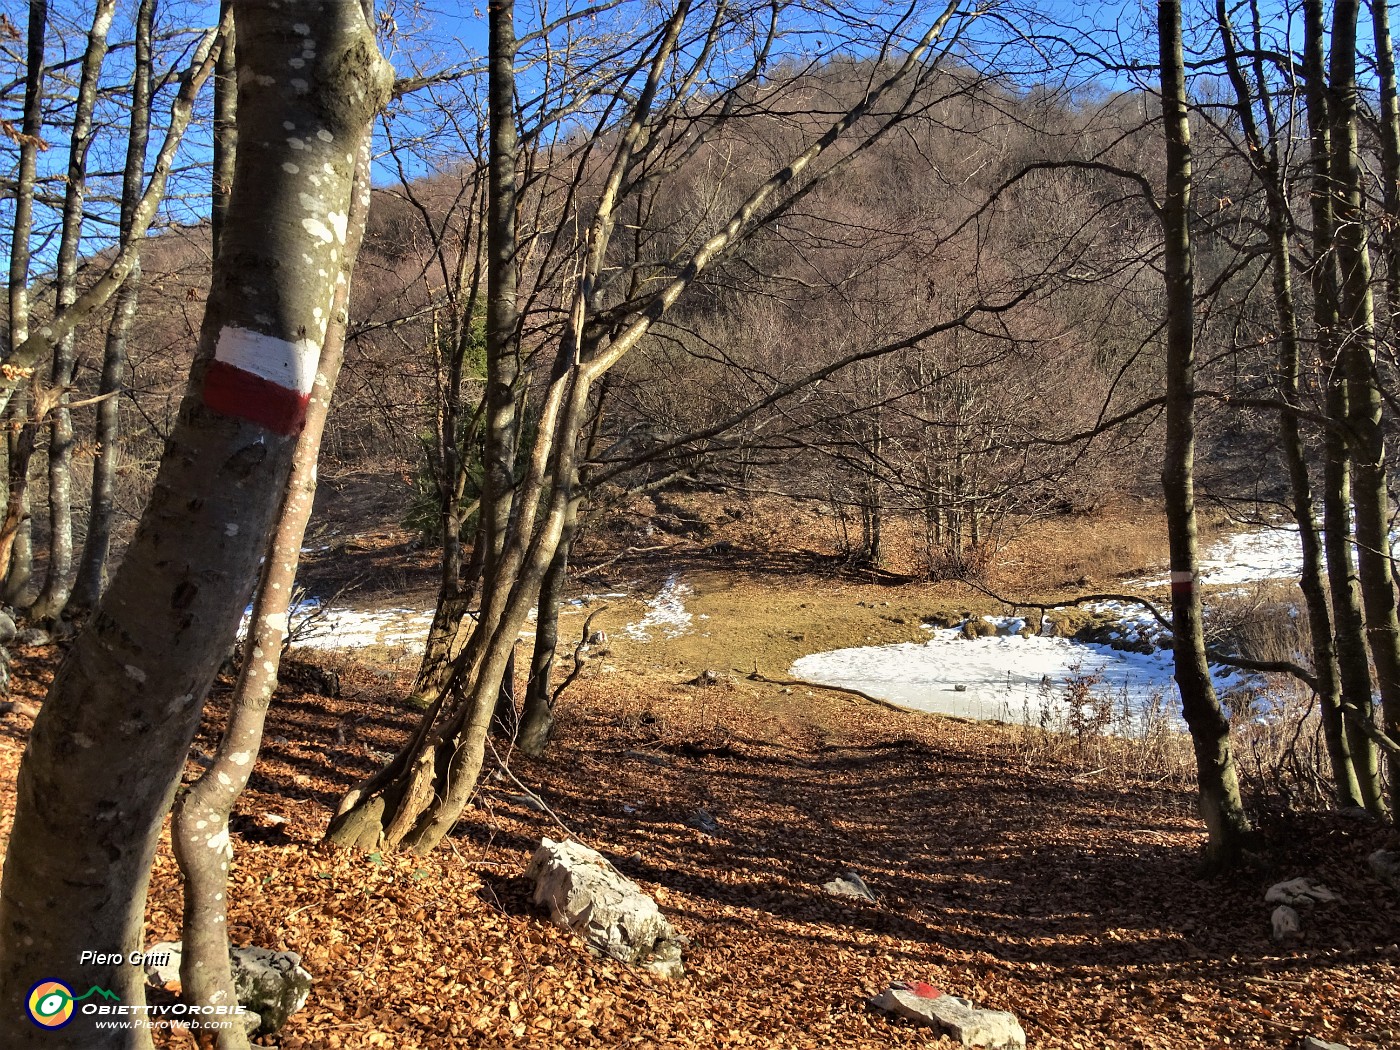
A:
[{"xmin": 204, "ymin": 328, "xmax": 321, "ymax": 435}]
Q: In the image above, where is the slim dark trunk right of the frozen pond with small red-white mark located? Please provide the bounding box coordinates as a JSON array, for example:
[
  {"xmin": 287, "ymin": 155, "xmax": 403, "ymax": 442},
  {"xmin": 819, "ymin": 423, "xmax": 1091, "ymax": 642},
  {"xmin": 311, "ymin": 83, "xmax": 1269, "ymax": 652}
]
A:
[{"xmin": 1156, "ymin": 0, "xmax": 1250, "ymax": 868}]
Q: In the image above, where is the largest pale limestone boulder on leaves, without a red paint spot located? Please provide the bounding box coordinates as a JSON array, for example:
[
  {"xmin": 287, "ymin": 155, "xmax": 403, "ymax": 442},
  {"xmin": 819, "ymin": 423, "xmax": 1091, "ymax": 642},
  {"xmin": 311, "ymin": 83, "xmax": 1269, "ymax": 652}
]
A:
[{"xmin": 525, "ymin": 839, "xmax": 685, "ymax": 977}]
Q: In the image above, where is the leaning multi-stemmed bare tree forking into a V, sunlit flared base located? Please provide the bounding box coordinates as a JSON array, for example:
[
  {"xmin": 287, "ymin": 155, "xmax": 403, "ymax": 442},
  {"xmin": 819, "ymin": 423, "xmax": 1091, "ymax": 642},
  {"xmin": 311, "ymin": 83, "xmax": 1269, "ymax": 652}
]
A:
[{"xmin": 328, "ymin": 0, "xmax": 991, "ymax": 851}]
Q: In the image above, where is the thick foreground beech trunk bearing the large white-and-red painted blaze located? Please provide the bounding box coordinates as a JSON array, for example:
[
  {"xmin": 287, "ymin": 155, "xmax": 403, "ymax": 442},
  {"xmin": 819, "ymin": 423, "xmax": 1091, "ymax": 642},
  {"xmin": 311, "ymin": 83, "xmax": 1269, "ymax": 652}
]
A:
[{"xmin": 0, "ymin": 0, "xmax": 392, "ymax": 1050}]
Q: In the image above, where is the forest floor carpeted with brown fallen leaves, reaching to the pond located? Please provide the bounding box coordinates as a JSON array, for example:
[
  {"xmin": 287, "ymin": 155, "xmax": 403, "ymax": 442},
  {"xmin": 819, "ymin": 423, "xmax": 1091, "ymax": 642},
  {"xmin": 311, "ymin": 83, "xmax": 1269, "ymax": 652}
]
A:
[{"xmin": 0, "ymin": 495, "xmax": 1400, "ymax": 1050}]
